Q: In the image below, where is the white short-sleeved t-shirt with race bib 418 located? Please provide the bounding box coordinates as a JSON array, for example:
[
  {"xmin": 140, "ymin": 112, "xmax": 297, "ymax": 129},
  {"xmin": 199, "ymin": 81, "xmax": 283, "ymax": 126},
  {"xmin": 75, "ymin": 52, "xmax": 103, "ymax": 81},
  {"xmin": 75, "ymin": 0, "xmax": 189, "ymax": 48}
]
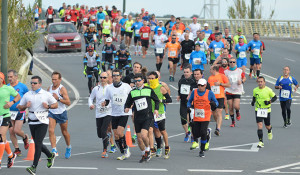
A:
[{"xmin": 105, "ymin": 83, "xmax": 132, "ymax": 117}]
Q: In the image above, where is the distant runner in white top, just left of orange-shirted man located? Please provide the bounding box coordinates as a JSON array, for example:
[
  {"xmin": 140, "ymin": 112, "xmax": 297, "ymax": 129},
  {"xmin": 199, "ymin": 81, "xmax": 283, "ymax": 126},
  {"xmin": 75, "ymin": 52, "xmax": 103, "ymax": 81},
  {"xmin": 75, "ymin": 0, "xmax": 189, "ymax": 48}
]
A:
[{"xmin": 152, "ymin": 28, "xmax": 168, "ymax": 71}]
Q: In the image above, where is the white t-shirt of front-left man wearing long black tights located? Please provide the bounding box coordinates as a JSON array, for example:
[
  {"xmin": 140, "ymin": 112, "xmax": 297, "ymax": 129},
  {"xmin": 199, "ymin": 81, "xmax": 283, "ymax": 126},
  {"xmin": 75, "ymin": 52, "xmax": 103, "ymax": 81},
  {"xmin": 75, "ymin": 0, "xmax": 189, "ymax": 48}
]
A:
[{"xmin": 20, "ymin": 89, "xmax": 57, "ymax": 125}]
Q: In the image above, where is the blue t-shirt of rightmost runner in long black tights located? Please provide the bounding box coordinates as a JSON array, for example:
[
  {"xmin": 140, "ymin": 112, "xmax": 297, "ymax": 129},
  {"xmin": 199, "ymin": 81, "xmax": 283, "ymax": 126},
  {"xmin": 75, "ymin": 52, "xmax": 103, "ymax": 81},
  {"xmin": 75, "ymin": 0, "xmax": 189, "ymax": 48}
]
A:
[{"xmin": 275, "ymin": 76, "xmax": 298, "ymax": 101}]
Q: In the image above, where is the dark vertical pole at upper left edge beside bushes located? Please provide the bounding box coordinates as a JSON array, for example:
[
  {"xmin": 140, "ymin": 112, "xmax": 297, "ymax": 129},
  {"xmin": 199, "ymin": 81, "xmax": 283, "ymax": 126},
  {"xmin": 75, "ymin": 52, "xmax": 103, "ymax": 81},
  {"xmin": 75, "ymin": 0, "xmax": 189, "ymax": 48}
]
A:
[{"xmin": 1, "ymin": 0, "xmax": 8, "ymax": 82}]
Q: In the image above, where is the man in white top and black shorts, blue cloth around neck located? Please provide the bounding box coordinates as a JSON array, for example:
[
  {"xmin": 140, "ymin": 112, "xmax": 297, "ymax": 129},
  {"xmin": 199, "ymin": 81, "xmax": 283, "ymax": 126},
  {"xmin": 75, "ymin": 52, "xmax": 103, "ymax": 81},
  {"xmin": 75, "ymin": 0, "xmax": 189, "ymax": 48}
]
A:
[{"xmin": 224, "ymin": 58, "xmax": 246, "ymax": 127}]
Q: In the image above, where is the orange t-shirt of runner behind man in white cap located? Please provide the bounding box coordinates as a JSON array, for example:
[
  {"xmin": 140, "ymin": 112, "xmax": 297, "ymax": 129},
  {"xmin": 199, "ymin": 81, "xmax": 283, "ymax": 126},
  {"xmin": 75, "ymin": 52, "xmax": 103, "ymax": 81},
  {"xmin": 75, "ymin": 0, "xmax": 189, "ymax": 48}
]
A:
[{"xmin": 207, "ymin": 73, "xmax": 229, "ymax": 99}]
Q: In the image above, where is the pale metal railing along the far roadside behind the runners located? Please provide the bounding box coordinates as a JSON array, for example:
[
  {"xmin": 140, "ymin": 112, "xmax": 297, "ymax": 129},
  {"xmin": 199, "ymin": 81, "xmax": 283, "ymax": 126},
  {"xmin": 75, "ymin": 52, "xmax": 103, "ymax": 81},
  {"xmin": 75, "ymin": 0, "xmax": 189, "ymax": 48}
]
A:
[{"xmin": 41, "ymin": 18, "xmax": 300, "ymax": 38}]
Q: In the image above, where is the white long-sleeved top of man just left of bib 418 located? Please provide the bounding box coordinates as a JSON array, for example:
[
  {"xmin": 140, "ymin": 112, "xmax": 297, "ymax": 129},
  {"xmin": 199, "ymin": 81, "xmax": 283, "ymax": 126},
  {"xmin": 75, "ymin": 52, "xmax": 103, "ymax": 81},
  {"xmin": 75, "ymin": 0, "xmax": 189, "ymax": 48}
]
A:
[{"xmin": 89, "ymin": 85, "xmax": 111, "ymax": 118}]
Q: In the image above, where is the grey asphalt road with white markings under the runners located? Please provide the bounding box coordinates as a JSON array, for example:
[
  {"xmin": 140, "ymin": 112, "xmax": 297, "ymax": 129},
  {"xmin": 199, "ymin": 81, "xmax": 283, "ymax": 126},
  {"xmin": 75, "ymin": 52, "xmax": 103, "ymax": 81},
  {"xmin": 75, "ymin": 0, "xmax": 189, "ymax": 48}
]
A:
[{"xmin": 0, "ymin": 36, "xmax": 300, "ymax": 175}]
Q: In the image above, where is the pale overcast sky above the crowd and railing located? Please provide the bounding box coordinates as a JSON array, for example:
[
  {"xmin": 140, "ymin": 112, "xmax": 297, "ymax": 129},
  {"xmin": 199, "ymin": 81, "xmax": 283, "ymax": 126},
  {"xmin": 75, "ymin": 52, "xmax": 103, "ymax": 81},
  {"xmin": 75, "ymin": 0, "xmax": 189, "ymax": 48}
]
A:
[{"xmin": 22, "ymin": 0, "xmax": 300, "ymax": 20}]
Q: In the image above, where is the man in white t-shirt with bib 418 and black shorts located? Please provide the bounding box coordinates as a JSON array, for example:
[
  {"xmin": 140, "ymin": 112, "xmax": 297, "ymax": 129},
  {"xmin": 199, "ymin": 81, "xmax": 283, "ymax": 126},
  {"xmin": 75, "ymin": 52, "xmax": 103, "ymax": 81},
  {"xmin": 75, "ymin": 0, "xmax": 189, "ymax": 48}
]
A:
[{"xmin": 101, "ymin": 69, "xmax": 132, "ymax": 160}]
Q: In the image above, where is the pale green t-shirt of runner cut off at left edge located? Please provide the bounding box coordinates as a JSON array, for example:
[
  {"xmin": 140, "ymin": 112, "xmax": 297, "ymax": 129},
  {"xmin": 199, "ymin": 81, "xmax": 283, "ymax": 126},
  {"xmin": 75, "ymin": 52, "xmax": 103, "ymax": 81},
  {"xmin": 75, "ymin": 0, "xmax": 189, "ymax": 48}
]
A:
[{"xmin": 0, "ymin": 85, "xmax": 18, "ymax": 118}]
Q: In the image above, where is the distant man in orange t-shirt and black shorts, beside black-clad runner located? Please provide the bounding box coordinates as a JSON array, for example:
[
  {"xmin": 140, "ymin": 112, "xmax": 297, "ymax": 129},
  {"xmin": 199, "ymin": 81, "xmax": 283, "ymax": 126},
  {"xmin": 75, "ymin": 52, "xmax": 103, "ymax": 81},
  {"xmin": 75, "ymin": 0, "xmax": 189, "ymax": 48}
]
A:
[{"xmin": 165, "ymin": 35, "xmax": 181, "ymax": 82}]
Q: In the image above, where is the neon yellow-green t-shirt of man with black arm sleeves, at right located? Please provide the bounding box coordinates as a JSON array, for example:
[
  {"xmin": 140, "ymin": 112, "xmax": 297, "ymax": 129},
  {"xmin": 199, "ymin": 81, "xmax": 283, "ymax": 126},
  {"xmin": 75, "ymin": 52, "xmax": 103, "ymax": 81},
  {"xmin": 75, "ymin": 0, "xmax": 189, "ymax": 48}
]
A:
[{"xmin": 253, "ymin": 86, "xmax": 275, "ymax": 112}]
